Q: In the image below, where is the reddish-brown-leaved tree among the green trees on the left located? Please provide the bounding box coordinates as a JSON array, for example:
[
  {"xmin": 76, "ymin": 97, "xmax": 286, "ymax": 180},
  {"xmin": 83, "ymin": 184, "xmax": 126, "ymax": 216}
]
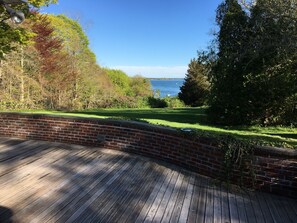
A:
[{"xmin": 32, "ymin": 15, "xmax": 73, "ymax": 108}]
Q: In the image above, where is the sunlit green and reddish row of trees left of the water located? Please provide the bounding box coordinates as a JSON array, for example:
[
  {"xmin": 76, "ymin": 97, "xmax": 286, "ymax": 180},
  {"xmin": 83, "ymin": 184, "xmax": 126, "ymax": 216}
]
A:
[{"xmin": 0, "ymin": 11, "xmax": 152, "ymax": 110}]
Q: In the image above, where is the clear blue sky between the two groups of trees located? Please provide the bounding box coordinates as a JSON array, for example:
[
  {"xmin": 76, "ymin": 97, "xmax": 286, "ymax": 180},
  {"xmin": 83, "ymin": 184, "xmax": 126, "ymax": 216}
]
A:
[{"xmin": 42, "ymin": 0, "xmax": 221, "ymax": 78}]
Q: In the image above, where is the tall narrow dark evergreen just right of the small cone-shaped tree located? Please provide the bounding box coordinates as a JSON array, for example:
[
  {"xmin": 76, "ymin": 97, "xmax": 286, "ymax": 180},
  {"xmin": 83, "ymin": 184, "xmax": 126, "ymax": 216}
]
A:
[{"xmin": 208, "ymin": 0, "xmax": 248, "ymax": 125}]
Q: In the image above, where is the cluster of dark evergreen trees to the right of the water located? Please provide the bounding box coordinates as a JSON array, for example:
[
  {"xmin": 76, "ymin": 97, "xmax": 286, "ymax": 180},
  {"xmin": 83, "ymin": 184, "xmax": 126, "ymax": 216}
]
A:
[{"xmin": 179, "ymin": 0, "xmax": 297, "ymax": 125}]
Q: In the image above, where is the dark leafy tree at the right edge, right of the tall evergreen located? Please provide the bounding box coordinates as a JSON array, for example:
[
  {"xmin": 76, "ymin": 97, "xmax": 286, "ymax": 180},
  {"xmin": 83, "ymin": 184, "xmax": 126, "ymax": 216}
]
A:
[{"xmin": 246, "ymin": 0, "xmax": 297, "ymax": 124}]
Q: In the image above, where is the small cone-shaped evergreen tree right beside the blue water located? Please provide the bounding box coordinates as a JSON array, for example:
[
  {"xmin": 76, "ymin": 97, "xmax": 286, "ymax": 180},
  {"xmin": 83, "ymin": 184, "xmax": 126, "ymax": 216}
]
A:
[{"xmin": 178, "ymin": 52, "xmax": 210, "ymax": 107}]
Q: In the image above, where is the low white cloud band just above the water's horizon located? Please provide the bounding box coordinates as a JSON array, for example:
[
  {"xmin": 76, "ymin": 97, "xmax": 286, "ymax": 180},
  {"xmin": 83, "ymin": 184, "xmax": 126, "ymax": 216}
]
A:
[{"xmin": 110, "ymin": 66, "xmax": 187, "ymax": 78}]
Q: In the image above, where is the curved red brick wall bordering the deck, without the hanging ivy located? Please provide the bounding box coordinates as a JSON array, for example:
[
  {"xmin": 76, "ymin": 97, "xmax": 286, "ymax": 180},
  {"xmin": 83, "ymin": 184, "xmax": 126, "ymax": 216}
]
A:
[{"xmin": 0, "ymin": 113, "xmax": 297, "ymax": 198}]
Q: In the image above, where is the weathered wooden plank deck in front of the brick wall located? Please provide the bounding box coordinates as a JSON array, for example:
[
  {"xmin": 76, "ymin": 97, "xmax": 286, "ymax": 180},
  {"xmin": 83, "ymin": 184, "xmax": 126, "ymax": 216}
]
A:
[{"xmin": 0, "ymin": 138, "xmax": 297, "ymax": 223}]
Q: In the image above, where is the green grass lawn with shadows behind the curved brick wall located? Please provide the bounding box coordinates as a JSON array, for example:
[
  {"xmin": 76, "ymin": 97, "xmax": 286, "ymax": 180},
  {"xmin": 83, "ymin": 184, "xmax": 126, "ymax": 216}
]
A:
[{"xmin": 8, "ymin": 107, "xmax": 297, "ymax": 149}]
